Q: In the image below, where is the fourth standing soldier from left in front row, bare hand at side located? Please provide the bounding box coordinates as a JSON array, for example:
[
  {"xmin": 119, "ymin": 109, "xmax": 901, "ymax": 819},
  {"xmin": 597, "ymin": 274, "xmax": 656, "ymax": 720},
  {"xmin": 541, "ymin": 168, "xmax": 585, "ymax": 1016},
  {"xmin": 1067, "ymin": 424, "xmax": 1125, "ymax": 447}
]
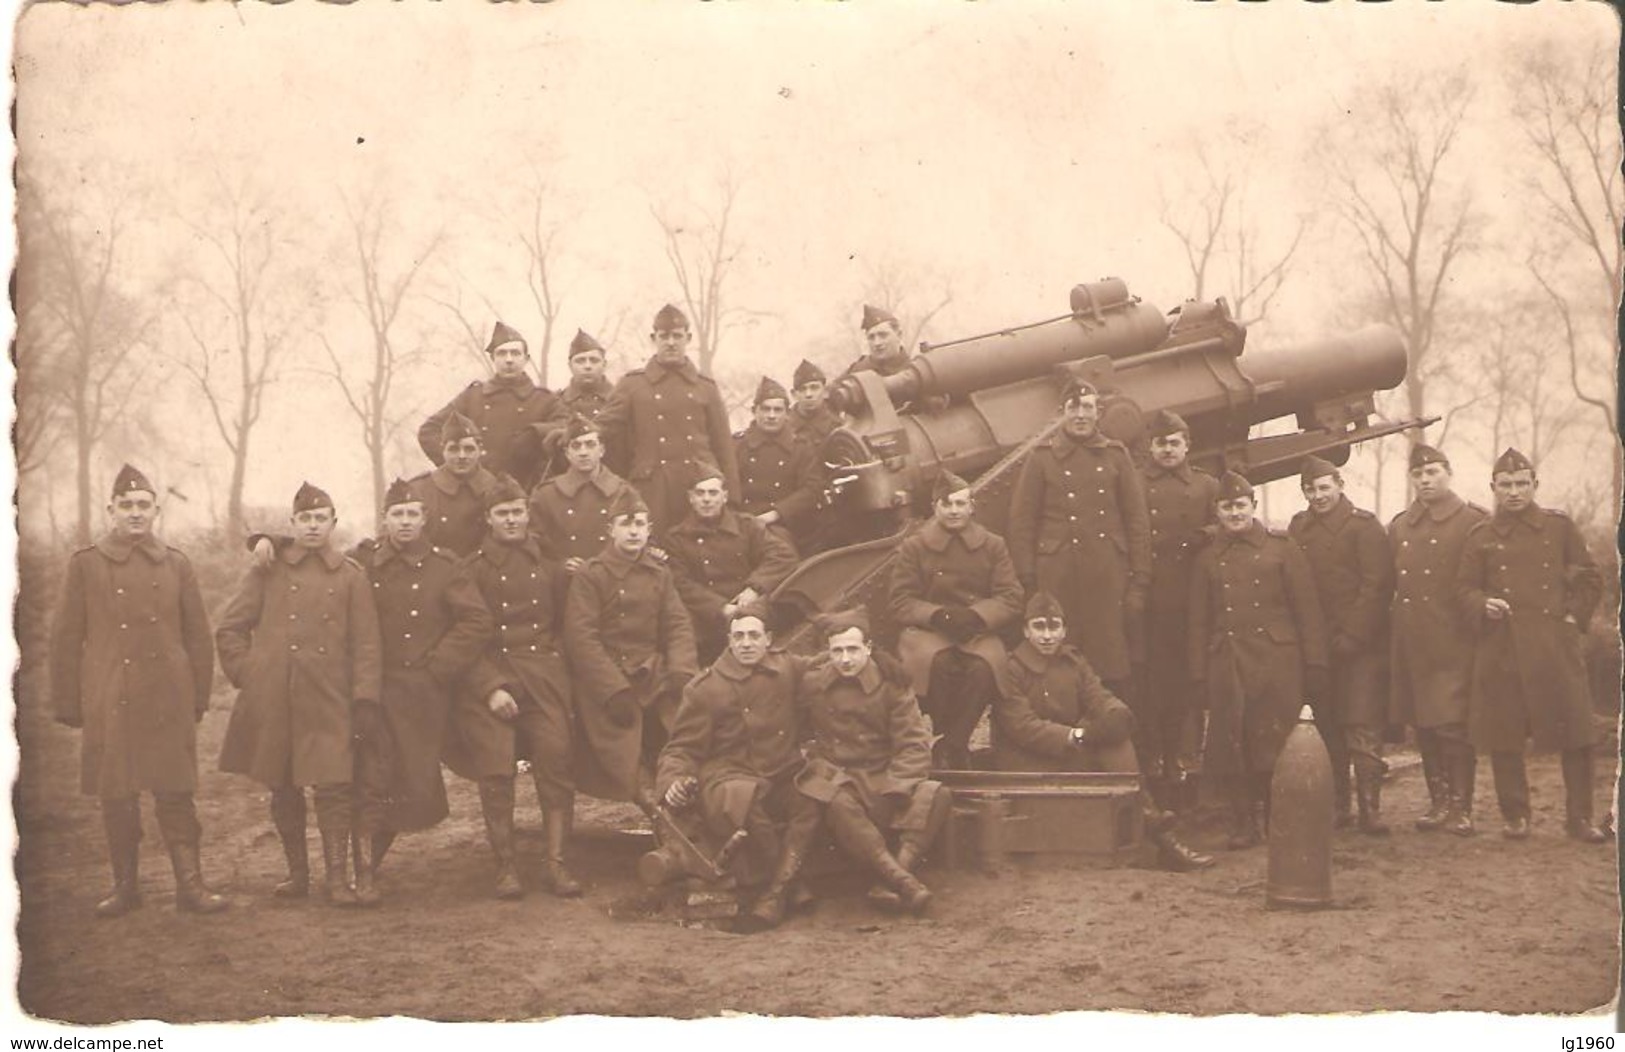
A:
[{"xmin": 445, "ymin": 478, "xmax": 582, "ymax": 899}]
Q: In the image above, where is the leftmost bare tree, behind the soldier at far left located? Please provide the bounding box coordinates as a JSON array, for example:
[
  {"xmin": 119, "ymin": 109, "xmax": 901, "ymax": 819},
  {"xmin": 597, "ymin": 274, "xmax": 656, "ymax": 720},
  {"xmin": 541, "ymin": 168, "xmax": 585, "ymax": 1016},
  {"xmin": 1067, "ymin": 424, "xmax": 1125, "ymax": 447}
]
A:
[{"xmin": 16, "ymin": 166, "xmax": 156, "ymax": 545}]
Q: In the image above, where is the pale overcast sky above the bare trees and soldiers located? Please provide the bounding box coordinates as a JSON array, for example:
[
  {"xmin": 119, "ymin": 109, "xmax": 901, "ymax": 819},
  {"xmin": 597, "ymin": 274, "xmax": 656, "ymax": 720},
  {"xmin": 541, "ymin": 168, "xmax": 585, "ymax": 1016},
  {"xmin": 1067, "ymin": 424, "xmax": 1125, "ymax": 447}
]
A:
[{"xmin": 18, "ymin": 0, "xmax": 1615, "ymax": 536}]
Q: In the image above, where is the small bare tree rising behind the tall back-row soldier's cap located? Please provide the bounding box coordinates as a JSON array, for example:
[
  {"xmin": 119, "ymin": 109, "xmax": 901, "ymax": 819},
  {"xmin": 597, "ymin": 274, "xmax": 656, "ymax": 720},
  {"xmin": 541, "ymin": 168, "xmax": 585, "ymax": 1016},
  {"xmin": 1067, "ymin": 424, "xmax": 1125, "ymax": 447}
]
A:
[{"xmin": 648, "ymin": 176, "xmax": 754, "ymax": 376}]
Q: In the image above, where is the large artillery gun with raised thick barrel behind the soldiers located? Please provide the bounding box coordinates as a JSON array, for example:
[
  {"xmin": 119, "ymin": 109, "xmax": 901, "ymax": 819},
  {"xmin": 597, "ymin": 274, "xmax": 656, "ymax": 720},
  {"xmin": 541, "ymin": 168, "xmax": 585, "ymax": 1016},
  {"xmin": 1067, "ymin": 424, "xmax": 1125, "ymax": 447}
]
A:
[{"xmin": 774, "ymin": 278, "xmax": 1432, "ymax": 636}]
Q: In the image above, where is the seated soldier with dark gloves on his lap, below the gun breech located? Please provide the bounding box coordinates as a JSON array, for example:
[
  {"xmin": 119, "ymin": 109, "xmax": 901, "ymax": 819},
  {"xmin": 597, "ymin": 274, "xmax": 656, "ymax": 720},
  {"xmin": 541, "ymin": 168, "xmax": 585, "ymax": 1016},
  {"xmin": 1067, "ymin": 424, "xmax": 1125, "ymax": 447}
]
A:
[{"xmin": 891, "ymin": 472, "xmax": 1022, "ymax": 771}]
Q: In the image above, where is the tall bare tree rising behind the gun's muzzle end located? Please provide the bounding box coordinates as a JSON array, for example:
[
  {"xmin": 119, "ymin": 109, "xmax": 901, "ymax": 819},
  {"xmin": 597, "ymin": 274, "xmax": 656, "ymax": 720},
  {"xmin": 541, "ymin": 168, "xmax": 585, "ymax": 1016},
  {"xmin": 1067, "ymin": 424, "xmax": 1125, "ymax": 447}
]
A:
[{"xmin": 1321, "ymin": 70, "xmax": 1477, "ymax": 442}]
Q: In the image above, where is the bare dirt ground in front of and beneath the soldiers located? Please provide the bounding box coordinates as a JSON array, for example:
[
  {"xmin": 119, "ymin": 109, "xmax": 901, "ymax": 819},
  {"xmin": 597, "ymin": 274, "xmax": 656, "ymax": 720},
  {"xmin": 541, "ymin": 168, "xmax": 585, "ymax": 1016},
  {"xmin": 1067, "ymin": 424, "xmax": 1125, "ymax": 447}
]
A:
[{"xmin": 15, "ymin": 656, "xmax": 1620, "ymax": 1023}]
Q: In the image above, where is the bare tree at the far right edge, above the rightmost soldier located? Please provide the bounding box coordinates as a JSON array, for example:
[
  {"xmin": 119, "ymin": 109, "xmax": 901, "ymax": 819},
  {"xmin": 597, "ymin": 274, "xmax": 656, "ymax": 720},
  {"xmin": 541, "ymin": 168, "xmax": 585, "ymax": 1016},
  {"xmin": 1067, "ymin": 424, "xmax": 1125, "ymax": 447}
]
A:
[{"xmin": 1508, "ymin": 39, "xmax": 1625, "ymax": 509}]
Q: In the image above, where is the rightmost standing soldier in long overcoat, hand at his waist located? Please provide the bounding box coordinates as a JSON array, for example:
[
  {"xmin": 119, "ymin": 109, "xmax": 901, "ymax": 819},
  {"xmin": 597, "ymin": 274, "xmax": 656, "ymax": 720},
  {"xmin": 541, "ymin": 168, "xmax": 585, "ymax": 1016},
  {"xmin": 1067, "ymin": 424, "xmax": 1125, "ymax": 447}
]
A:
[{"xmin": 1456, "ymin": 449, "xmax": 1607, "ymax": 844}]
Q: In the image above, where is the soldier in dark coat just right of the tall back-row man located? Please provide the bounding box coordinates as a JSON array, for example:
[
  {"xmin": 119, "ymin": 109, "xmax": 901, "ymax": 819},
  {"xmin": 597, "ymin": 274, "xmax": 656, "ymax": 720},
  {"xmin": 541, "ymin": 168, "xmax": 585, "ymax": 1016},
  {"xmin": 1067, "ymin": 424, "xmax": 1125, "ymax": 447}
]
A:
[{"xmin": 733, "ymin": 376, "xmax": 819, "ymax": 548}]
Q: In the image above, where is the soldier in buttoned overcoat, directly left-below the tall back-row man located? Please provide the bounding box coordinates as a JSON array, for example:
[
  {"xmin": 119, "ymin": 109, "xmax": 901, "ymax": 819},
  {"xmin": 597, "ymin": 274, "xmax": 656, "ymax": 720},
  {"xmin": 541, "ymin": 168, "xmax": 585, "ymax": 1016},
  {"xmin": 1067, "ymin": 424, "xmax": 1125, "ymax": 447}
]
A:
[{"xmin": 530, "ymin": 416, "xmax": 627, "ymax": 574}]
